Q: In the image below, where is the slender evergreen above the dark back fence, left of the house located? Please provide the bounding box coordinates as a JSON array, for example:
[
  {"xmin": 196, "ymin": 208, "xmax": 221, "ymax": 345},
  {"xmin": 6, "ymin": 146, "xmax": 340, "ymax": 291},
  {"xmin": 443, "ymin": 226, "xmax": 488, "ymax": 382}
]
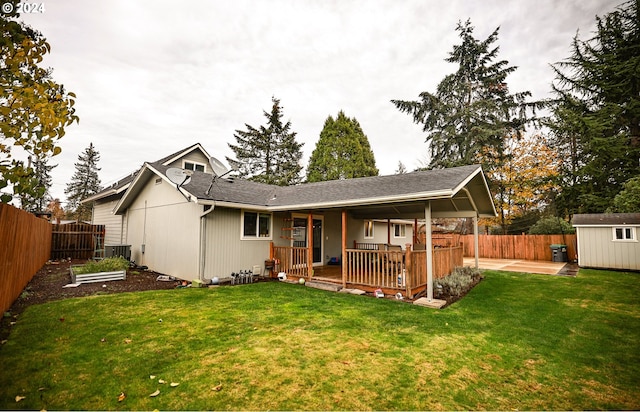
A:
[{"xmin": 64, "ymin": 143, "xmax": 100, "ymax": 220}]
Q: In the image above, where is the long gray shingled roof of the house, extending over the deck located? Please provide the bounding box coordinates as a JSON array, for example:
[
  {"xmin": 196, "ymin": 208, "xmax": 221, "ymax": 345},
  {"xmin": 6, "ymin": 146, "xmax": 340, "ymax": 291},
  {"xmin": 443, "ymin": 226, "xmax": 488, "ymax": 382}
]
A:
[{"xmin": 116, "ymin": 161, "xmax": 495, "ymax": 217}]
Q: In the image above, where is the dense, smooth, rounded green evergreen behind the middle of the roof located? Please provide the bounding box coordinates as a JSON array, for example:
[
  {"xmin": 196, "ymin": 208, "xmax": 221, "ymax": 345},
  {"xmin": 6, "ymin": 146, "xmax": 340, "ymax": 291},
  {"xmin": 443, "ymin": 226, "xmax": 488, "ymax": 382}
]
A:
[{"xmin": 307, "ymin": 111, "xmax": 378, "ymax": 182}]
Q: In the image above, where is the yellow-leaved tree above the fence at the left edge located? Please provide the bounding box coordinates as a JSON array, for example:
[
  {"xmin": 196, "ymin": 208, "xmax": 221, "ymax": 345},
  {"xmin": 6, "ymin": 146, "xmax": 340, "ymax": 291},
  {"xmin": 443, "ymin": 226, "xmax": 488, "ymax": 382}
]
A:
[{"xmin": 0, "ymin": 0, "xmax": 78, "ymax": 203}]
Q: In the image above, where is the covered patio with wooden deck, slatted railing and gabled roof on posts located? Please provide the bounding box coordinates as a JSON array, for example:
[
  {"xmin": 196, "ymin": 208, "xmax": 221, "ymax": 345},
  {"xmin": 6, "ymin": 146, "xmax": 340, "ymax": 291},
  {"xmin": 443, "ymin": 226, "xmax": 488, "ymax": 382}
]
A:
[{"xmin": 269, "ymin": 166, "xmax": 496, "ymax": 300}]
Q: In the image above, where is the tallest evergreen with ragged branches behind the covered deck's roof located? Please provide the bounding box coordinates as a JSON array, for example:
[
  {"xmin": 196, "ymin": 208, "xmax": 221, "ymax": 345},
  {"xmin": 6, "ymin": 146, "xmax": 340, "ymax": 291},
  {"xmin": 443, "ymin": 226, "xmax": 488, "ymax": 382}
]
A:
[{"xmin": 391, "ymin": 20, "xmax": 530, "ymax": 168}]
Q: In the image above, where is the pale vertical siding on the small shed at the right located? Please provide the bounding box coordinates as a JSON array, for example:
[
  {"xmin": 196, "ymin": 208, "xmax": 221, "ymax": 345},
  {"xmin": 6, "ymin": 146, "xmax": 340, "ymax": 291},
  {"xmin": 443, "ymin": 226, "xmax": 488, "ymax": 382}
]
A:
[{"xmin": 577, "ymin": 226, "xmax": 640, "ymax": 270}]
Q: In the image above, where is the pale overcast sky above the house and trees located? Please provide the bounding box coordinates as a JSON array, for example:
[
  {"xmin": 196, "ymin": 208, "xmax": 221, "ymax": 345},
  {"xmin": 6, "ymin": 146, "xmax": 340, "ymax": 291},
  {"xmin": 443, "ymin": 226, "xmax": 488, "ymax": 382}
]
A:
[{"xmin": 22, "ymin": 0, "xmax": 622, "ymax": 206}]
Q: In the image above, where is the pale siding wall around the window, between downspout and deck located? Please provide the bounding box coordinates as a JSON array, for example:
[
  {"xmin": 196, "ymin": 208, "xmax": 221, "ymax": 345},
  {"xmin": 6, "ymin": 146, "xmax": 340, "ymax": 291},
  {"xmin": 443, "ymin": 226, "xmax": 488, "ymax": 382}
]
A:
[{"xmin": 204, "ymin": 207, "xmax": 282, "ymax": 279}]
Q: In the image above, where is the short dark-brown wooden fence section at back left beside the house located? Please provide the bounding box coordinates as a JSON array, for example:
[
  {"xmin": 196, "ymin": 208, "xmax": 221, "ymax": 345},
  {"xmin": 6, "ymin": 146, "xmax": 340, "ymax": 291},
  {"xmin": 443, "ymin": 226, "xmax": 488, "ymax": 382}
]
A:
[{"xmin": 51, "ymin": 223, "xmax": 105, "ymax": 260}]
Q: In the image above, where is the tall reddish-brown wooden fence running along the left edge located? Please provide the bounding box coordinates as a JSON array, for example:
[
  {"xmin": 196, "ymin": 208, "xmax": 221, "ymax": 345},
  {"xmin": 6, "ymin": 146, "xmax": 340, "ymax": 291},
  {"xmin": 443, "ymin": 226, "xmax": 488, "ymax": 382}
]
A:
[{"xmin": 0, "ymin": 203, "xmax": 51, "ymax": 313}]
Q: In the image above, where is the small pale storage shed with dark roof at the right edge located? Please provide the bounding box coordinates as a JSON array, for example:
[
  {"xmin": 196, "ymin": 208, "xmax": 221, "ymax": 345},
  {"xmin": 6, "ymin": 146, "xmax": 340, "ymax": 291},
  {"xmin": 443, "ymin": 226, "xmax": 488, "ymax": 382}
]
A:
[{"xmin": 572, "ymin": 213, "xmax": 640, "ymax": 271}]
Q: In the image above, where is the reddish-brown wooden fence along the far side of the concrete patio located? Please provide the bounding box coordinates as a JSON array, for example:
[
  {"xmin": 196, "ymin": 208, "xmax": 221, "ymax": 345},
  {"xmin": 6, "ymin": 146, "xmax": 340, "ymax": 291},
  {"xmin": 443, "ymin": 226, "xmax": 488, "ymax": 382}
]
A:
[{"xmin": 452, "ymin": 235, "xmax": 578, "ymax": 261}]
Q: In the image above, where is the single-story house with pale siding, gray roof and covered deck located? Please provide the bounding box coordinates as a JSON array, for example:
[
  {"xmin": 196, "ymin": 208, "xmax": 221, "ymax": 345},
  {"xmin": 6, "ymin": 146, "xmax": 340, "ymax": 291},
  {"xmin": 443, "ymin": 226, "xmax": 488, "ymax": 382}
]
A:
[{"xmin": 84, "ymin": 144, "xmax": 496, "ymax": 300}]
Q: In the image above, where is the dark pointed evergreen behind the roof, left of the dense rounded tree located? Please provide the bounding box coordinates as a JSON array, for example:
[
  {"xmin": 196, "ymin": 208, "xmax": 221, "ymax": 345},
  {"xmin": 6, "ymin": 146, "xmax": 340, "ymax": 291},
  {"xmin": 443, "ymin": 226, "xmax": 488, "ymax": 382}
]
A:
[{"xmin": 227, "ymin": 97, "xmax": 303, "ymax": 186}]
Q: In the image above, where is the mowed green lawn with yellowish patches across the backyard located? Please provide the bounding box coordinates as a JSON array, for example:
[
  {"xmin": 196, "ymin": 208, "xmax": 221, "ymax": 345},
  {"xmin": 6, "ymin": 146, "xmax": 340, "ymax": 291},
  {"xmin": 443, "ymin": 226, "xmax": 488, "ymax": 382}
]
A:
[{"xmin": 0, "ymin": 270, "xmax": 640, "ymax": 410}]
